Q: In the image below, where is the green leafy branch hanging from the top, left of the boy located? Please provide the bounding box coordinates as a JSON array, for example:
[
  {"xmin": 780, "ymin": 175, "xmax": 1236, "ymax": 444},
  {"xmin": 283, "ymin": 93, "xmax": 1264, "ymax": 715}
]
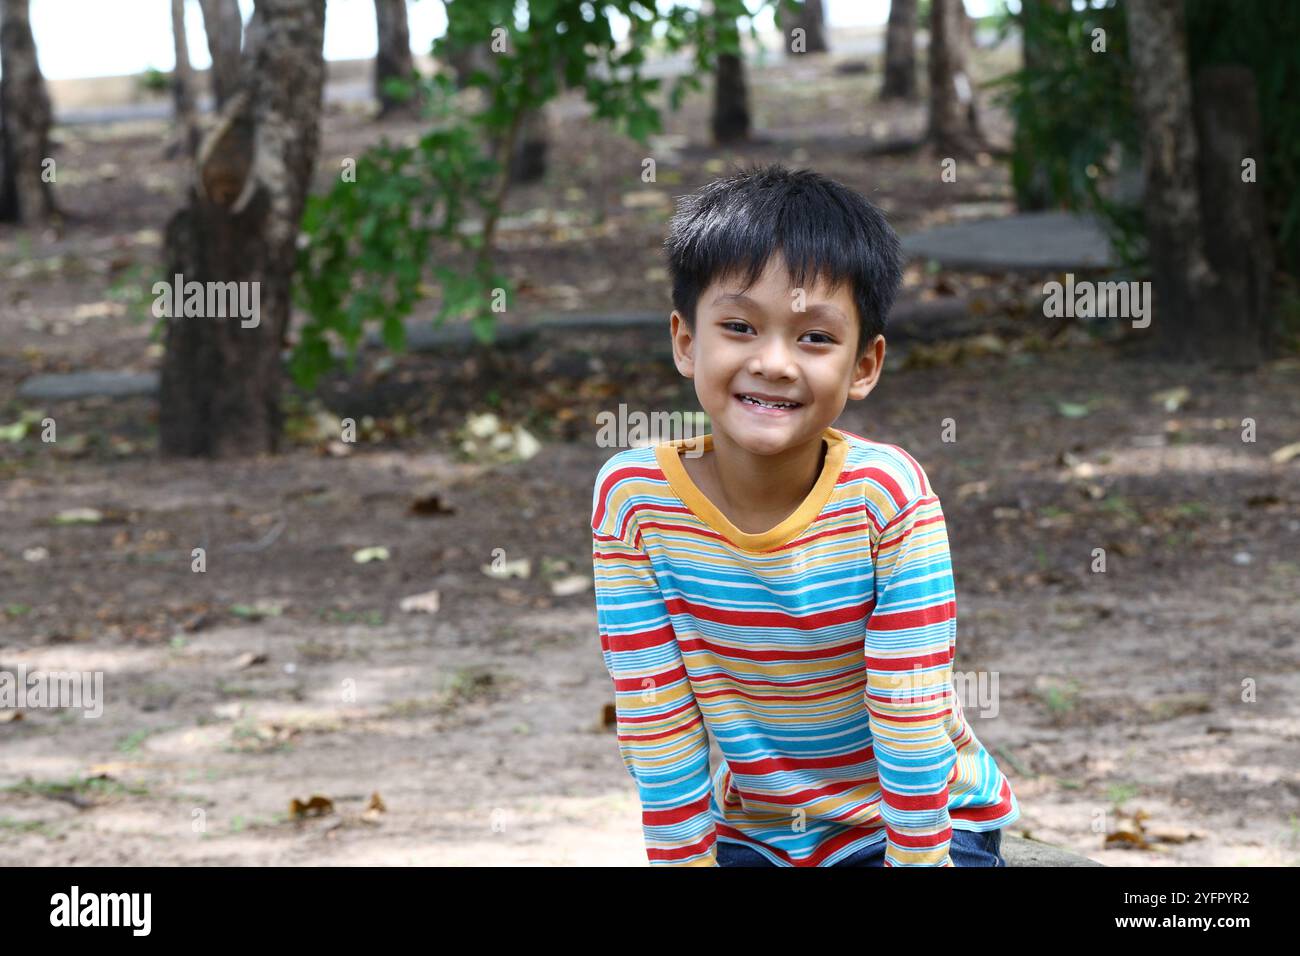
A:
[{"xmin": 290, "ymin": 0, "xmax": 779, "ymax": 388}]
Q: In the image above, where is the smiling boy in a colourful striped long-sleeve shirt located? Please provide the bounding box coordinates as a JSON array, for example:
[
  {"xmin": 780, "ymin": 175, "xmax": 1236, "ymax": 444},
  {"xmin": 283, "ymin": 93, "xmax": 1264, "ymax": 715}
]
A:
[{"xmin": 592, "ymin": 165, "xmax": 1021, "ymax": 866}]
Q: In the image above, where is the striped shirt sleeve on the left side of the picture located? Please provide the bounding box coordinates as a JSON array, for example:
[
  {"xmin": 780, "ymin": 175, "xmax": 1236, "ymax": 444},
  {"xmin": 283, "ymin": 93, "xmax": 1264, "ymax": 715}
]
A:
[{"xmin": 592, "ymin": 528, "xmax": 718, "ymax": 866}]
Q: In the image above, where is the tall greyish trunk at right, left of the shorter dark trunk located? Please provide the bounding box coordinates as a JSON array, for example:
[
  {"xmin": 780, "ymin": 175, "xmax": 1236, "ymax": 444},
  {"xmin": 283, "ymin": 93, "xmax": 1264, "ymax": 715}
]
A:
[{"xmin": 1125, "ymin": 0, "xmax": 1211, "ymax": 358}]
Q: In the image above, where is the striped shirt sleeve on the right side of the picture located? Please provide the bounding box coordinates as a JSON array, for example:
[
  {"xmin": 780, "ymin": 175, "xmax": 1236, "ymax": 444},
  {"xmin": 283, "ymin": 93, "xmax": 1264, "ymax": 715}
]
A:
[{"xmin": 866, "ymin": 488, "xmax": 957, "ymax": 866}]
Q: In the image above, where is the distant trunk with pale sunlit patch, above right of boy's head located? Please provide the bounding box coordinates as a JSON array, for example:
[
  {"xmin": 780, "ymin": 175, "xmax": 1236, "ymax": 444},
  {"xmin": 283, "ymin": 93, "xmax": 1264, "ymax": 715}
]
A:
[{"xmin": 927, "ymin": 0, "xmax": 983, "ymax": 157}]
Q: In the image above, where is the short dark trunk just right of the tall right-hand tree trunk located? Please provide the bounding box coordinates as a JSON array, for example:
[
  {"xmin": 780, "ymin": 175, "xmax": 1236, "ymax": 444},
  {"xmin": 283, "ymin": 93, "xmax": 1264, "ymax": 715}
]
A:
[{"xmin": 1193, "ymin": 65, "xmax": 1278, "ymax": 368}]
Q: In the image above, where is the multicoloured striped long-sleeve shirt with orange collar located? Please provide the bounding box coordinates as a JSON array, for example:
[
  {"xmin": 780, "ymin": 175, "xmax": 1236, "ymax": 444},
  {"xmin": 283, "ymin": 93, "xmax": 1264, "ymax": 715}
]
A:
[{"xmin": 592, "ymin": 428, "xmax": 1021, "ymax": 866}]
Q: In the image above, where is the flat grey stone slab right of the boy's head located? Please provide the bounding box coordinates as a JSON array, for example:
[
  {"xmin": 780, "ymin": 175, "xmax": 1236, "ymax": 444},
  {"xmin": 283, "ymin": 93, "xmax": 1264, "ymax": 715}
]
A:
[{"xmin": 902, "ymin": 212, "xmax": 1119, "ymax": 272}]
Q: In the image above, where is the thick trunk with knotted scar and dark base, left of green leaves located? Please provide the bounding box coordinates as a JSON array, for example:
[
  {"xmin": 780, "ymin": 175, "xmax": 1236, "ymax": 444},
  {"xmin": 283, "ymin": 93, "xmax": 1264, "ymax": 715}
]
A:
[{"xmin": 155, "ymin": 0, "xmax": 325, "ymax": 458}]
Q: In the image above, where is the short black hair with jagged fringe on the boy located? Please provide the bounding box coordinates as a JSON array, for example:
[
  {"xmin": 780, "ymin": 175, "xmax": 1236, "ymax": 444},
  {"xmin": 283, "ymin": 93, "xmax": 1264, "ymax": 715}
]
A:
[{"xmin": 664, "ymin": 163, "xmax": 902, "ymax": 359}]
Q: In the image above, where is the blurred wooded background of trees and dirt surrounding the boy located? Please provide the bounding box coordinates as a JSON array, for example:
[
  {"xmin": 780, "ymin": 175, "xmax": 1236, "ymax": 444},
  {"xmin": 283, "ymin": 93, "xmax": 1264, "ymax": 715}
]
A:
[{"xmin": 0, "ymin": 0, "xmax": 1300, "ymax": 866}]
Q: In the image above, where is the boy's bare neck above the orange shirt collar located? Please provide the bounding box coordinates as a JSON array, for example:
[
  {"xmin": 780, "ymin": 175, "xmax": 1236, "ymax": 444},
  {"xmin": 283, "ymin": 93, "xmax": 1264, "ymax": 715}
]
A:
[{"xmin": 697, "ymin": 432, "xmax": 826, "ymax": 532}]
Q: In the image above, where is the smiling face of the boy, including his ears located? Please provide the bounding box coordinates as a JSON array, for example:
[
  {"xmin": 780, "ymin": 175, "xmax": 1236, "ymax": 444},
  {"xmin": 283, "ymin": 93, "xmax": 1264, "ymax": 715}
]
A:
[{"xmin": 671, "ymin": 252, "xmax": 885, "ymax": 455}]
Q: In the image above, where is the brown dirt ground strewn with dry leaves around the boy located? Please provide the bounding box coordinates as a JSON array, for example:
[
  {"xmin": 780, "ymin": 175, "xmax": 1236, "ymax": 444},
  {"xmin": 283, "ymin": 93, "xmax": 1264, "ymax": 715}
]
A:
[{"xmin": 0, "ymin": 44, "xmax": 1300, "ymax": 866}]
